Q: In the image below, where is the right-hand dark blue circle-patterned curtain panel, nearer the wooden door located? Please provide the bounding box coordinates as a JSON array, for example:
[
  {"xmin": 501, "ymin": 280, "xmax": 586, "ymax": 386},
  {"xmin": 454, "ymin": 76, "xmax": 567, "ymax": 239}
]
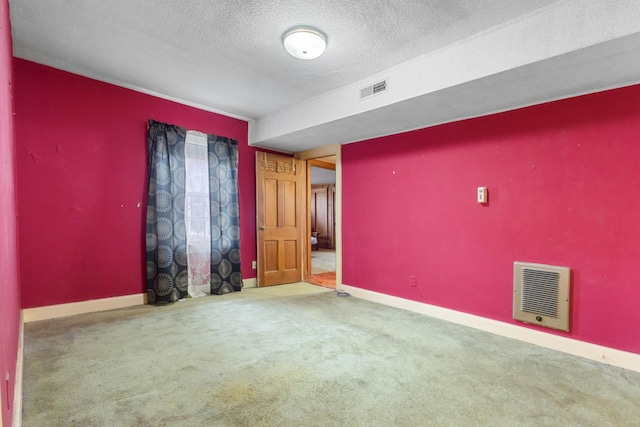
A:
[{"xmin": 207, "ymin": 135, "xmax": 242, "ymax": 294}]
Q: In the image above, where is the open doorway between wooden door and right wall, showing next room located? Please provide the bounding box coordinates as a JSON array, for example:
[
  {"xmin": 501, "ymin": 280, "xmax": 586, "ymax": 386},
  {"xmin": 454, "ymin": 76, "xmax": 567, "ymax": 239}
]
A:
[{"xmin": 305, "ymin": 155, "xmax": 336, "ymax": 289}]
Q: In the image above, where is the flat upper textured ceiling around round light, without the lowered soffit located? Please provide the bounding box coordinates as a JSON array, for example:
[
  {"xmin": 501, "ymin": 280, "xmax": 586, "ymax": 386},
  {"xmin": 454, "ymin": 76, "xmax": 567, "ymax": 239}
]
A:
[{"xmin": 10, "ymin": 0, "xmax": 553, "ymax": 118}]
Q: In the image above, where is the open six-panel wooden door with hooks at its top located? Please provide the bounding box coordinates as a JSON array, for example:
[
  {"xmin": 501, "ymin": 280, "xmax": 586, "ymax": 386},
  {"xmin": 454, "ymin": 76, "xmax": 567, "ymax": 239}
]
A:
[{"xmin": 256, "ymin": 152, "xmax": 309, "ymax": 286}]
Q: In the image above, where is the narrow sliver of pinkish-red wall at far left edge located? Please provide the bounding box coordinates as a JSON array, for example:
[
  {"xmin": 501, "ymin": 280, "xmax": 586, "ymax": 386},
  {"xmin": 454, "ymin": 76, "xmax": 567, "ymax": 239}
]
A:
[{"xmin": 0, "ymin": 0, "xmax": 20, "ymax": 426}]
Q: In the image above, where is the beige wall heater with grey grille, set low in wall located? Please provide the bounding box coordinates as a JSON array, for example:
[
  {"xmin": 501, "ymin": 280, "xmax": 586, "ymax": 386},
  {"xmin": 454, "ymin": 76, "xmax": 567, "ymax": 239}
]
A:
[{"xmin": 513, "ymin": 262, "xmax": 571, "ymax": 332}]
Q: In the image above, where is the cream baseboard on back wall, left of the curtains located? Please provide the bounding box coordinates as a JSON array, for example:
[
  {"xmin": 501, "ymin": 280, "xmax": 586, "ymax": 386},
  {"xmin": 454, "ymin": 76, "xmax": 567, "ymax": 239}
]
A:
[{"xmin": 22, "ymin": 293, "xmax": 147, "ymax": 323}]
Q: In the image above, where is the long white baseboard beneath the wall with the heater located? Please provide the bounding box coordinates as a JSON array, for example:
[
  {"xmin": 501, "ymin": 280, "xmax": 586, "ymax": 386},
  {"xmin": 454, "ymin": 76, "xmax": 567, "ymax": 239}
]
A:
[{"xmin": 342, "ymin": 285, "xmax": 640, "ymax": 372}]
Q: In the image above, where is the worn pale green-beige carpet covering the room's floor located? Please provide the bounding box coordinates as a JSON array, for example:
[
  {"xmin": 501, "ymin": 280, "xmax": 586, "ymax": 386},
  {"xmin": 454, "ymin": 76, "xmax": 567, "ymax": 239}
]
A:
[{"xmin": 23, "ymin": 284, "xmax": 640, "ymax": 427}]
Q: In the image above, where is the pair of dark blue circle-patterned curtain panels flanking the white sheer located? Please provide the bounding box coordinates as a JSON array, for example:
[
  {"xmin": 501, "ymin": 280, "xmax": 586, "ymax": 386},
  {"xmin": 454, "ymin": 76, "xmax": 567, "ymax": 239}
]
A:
[{"xmin": 145, "ymin": 120, "xmax": 242, "ymax": 304}]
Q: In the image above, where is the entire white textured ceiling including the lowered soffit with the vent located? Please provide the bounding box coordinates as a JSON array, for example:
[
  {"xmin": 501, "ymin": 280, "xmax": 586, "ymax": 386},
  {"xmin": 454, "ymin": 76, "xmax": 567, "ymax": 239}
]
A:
[{"xmin": 10, "ymin": 0, "xmax": 640, "ymax": 152}]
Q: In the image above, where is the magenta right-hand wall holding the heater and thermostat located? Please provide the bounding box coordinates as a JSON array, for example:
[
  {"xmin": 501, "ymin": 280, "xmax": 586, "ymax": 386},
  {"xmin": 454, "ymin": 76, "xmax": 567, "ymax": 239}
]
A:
[{"xmin": 342, "ymin": 86, "xmax": 640, "ymax": 353}]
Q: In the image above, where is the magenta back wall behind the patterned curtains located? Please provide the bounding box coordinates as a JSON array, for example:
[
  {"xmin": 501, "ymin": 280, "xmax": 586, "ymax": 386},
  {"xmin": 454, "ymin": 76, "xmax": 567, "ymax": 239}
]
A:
[{"xmin": 15, "ymin": 59, "xmax": 256, "ymax": 308}]
